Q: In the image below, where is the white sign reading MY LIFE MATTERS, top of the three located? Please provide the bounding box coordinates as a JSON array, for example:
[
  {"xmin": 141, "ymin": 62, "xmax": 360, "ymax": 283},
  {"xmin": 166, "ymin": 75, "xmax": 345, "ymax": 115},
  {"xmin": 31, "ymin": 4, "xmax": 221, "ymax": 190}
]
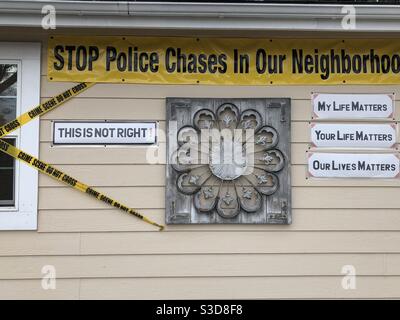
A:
[{"xmin": 312, "ymin": 93, "xmax": 394, "ymax": 119}]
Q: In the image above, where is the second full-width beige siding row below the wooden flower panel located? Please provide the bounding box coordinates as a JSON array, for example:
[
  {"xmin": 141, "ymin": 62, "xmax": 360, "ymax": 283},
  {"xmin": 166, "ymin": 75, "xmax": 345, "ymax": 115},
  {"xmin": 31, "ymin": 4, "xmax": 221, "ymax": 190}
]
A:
[{"xmin": 0, "ymin": 254, "xmax": 388, "ymax": 280}]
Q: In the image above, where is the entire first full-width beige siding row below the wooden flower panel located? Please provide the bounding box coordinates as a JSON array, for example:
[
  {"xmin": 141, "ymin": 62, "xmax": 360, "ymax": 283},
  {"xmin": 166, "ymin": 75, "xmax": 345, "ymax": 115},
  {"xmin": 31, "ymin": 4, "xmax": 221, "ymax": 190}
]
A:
[{"xmin": 0, "ymin": 231, "xmax": 400, "ymax": 256}]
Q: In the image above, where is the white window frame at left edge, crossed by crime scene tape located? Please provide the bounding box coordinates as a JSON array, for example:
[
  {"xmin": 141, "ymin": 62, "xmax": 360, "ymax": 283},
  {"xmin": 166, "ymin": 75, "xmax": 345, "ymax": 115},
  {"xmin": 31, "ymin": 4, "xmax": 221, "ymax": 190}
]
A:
[{"xmin": 0, "ymin": 42, "xmax": 41, "ymax": 230}]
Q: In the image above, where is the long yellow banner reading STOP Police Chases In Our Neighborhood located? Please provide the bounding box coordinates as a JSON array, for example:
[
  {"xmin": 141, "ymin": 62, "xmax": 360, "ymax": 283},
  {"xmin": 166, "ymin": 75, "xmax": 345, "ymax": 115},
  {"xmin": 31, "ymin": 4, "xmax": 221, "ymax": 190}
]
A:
[{"xmin": 48, "ymin": 36, "xmax": 400, "ymax": 85}]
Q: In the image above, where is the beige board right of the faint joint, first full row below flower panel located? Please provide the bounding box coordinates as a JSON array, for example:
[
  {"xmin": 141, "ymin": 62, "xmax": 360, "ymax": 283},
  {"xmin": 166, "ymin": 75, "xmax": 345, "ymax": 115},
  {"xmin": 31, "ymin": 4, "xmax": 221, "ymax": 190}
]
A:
[{"xmin": 81, "ymin": 231, "xmax": 400, "ymax": 255}]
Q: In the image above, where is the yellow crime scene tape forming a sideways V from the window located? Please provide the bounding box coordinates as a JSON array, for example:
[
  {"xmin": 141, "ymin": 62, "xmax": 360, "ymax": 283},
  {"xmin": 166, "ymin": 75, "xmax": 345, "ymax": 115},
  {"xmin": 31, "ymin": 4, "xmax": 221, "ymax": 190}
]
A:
[{"xmin": 0, "ymin": 83, "xmax": 164, "ymax": 231}]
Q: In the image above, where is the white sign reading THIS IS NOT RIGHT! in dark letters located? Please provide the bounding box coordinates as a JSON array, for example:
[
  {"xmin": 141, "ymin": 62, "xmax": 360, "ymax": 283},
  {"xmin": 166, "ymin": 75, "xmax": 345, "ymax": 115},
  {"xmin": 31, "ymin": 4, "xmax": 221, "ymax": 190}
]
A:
[{"xmin": 53, "ymin": 121, "xmax": 157, "ymax": 145}]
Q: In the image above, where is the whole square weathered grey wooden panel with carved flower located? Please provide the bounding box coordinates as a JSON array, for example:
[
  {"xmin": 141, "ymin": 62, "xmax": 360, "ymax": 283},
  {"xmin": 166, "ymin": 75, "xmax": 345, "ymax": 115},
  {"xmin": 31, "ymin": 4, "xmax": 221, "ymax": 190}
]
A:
[{"xmin": 166, "ymin": 98, "xmax": 292, "ymax": 224}]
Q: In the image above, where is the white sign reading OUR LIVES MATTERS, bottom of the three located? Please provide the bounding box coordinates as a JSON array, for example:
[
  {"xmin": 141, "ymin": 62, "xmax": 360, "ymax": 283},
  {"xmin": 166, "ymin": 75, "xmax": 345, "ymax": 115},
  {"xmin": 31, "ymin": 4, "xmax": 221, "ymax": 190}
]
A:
[{"xmin": 308, "ymin": 152, "xmax": 400, "ymax": 178}]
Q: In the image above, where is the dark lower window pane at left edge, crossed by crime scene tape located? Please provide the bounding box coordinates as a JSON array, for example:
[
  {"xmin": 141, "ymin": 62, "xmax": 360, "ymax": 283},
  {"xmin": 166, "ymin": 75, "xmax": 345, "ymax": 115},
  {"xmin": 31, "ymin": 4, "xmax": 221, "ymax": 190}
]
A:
[{"xmin": 0, "ymin": 139, "xmax": 15, "ymax": 207}]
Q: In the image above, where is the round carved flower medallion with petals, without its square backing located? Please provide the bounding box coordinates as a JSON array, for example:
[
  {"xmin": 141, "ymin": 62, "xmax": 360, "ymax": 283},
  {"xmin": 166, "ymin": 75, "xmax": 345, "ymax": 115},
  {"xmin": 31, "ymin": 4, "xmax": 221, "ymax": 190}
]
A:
[{"xmin": 171, "ymin": 103, "xmax": 287, "ymax": 219}]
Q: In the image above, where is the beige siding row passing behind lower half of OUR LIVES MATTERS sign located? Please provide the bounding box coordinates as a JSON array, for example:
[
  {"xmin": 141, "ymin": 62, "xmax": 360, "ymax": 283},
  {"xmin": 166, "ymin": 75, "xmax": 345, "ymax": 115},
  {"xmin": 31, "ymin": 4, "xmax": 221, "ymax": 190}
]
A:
[{"xmin": 39, "ymin": 164, "xmax": 400, "ymax": 188}]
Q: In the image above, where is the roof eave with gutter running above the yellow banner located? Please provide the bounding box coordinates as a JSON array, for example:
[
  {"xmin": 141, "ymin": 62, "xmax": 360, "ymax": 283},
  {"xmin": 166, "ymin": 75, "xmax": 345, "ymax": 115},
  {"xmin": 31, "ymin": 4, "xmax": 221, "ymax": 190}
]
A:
[{"xmin": 0, "ymin": 1, "xmax": 400, "ymax": 32}]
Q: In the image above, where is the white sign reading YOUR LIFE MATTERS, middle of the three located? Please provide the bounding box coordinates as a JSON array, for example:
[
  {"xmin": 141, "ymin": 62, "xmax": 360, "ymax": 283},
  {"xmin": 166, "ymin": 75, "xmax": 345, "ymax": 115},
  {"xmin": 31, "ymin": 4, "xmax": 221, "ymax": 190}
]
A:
[{"xmin": 311, "ymin": 123, "xmax": 397, "ymax": 148}]
